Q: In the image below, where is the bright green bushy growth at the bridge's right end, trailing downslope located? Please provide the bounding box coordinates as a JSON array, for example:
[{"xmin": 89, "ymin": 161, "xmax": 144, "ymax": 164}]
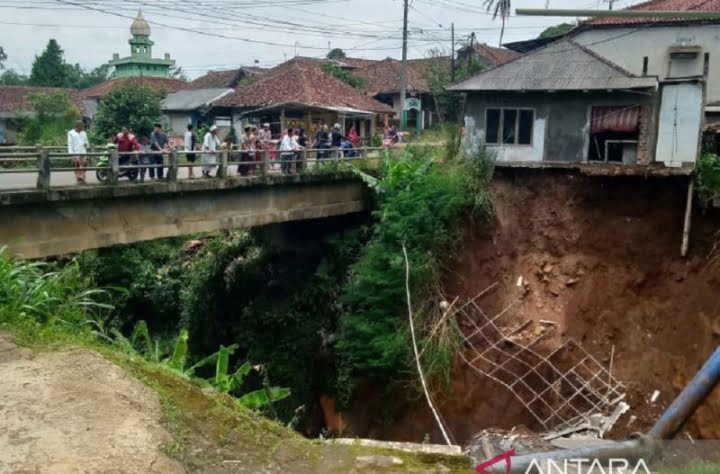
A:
[{"xmin": 336, "ymin": 148, "xmax": 489, "ymax": 401}]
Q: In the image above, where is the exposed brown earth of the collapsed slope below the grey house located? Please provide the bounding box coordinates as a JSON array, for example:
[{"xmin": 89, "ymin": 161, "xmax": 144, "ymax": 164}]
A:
[{"xmin": 367, "ymin": 170, "xmax": 720, "ymax": 443}]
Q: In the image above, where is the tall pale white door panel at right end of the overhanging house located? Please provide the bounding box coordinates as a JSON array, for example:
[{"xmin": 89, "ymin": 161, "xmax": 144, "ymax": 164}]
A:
[{"xmin": 655, "ymin": 83, "xmax": 703, "ymax": 167}]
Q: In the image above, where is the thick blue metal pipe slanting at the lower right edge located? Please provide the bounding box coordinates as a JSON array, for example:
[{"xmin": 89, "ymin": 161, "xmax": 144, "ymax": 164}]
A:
[{"xmin": 648, "ymin": 347, "xmax": 720, "ymax": 439}]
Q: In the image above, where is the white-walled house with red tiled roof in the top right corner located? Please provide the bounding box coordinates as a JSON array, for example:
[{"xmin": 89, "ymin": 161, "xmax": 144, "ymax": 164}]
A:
[{"xmin": 569, "ymin": 0, "xmax": 720, "ymax": 118}]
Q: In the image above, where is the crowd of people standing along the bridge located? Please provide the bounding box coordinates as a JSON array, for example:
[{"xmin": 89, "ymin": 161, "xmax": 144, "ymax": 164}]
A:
[{"xmin": 67, "ymin": 121, "xmax": 399, "ymax": 184}]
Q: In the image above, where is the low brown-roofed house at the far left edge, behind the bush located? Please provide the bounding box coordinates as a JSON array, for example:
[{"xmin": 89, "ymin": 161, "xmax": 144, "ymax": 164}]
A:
[{"xmin": 0, "ymin": 85, "xmax": 84, "ymax": 145}]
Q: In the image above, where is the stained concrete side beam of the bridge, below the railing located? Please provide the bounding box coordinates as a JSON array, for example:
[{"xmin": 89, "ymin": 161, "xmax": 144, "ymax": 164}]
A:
[{"xmin": 0, "ymin": 172, "xmax": 365, "ymax": 259}]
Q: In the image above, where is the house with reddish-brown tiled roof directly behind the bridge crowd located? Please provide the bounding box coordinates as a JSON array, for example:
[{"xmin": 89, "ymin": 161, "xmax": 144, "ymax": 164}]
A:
[{"xmin": 213, "ymin": 57, "xmax": 392, "ymax": 143}]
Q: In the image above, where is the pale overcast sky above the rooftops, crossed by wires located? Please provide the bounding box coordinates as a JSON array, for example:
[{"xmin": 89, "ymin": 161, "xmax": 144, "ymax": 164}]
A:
[{"xmin": 0, "ymin": 0, "xmax": 638, "ymax": 77}]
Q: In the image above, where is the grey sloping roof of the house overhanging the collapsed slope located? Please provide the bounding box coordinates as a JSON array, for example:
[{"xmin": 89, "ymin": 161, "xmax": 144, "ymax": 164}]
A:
[{"xmin": 448, "ymin": 39, "xmax": 657, "ymax": 92}]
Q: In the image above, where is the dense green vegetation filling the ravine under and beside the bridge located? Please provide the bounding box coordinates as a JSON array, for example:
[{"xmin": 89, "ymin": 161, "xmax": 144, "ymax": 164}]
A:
[{"xmin": 0, "ymin": 142, "xmax": 492, "ymax": 430}]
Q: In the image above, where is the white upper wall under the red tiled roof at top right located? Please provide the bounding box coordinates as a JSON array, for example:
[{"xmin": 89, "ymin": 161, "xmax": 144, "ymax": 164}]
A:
[{"xmin": 572, "ymin": 25, "xmax": 720, "ymax": 102}]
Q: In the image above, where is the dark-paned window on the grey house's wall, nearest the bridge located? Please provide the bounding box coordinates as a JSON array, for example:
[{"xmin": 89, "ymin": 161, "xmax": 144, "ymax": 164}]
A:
[{"xmin": 485, "ymin": 109, "xmax": 535, "ymax": 145}]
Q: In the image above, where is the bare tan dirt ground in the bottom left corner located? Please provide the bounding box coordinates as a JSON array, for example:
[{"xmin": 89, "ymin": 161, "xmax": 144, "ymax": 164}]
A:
[{"xmin": 0, "ymin": 333, "xmax": 185, "ymax": 474}]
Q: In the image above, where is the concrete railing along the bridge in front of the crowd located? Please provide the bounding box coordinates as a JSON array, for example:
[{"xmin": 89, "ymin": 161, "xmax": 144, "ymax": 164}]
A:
[{"xmin": 0, "ymin": 146, "xmax": 394, "ymax": 191}]
